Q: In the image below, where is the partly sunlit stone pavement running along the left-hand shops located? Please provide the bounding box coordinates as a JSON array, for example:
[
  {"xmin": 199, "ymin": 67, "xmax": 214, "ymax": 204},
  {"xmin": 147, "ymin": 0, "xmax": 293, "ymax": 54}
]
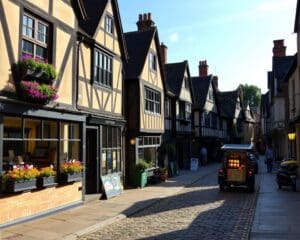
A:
[{"xmin": 0, "ymin": 164, "xmax": 220, "ymax": 240}]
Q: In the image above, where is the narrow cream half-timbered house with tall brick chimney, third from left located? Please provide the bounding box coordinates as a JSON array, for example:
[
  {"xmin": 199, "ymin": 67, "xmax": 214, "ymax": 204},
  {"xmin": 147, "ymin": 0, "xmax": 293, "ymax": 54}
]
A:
[{"xmin": 125, "ymin": 13, "xmax": 165, "ymax": 184}]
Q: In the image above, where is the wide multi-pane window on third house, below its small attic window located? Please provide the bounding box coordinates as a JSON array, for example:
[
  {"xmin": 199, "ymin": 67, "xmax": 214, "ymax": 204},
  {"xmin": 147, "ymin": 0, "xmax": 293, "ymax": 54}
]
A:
[{"xmin": 144, "ymin": 87, "xmax": 161, "ymax": 114}]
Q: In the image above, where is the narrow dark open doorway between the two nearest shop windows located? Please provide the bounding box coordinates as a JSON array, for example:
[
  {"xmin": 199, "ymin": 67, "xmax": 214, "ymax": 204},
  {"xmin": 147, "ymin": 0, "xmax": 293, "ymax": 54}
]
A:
[{"xmin": 85, "ymin": 128, "xmax": 100, "ymax": 194}]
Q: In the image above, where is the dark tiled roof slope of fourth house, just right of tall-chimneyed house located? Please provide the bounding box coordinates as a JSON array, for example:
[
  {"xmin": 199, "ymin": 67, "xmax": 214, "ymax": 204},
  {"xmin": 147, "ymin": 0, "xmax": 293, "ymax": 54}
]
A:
[{"xmin": 164, "ymin": 61, "xmax": 187, "ymax": 96}]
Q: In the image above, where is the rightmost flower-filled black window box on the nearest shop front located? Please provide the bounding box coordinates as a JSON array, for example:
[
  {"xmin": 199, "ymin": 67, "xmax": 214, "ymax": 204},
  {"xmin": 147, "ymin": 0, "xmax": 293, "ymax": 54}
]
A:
[{"xmin": 60, "ymin": 159, "xmax": 83, "ymax": 183}]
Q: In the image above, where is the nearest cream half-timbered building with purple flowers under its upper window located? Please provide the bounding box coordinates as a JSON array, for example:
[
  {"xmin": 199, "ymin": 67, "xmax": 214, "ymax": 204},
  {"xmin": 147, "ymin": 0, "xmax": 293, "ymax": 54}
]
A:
[{"xmin": 0, "ymin": 0, "xmax": 86, "ymax": 227}]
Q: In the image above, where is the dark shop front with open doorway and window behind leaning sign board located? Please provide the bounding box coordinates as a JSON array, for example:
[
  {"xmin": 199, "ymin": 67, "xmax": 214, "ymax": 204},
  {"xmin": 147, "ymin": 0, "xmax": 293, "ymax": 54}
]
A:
[{"xmin": 85, "ymin": 116, "xmax": 125, "ymax": 197}]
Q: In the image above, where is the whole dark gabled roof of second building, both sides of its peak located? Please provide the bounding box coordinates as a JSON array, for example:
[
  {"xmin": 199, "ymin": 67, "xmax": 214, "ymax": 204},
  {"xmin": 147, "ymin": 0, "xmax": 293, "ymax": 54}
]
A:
[{"xmin": 78, "ymin": 0, "xmax": 127, "ymax": 59}]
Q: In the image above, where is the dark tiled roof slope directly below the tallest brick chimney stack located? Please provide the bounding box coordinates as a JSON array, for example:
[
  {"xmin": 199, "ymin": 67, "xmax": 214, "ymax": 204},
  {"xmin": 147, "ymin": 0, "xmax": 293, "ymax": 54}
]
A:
[{"xmin": 124, "ymin": 28, "xmax": 156, "ymax": 79}]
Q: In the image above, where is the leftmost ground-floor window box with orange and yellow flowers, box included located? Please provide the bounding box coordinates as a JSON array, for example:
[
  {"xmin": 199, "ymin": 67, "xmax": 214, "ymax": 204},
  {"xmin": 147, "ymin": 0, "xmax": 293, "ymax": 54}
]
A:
[{"xmin": 2, "ymin": 164, "xmax": 39, "ymax": 193}]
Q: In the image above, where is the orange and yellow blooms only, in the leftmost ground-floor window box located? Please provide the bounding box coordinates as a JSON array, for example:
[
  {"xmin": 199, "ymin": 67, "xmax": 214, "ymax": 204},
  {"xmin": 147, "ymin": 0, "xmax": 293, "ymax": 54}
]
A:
[{"xmin": 3, "ymin": 164, "xmax": 40, "ymax": 182}]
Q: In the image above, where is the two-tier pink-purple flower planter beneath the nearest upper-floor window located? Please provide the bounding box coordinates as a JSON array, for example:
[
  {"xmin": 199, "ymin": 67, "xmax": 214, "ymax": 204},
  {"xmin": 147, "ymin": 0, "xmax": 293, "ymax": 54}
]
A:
[{"xmin": 13, "ymin": 55, "xmax": 58, "ymax": 104}]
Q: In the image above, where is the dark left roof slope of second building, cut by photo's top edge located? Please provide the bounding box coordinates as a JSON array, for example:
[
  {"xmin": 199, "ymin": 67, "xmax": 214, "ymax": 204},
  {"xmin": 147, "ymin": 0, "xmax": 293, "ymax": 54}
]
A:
[{"xmin": 79, "ymin": 0, "xmax": 108, "ymax": 37}]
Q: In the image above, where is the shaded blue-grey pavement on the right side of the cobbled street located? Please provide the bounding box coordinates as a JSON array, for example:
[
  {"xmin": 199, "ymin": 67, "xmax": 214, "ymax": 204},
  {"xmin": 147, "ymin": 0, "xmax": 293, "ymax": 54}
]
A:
[{"xmin": 250, "ymin": 157, "xmax": 300, "ymax": 240}]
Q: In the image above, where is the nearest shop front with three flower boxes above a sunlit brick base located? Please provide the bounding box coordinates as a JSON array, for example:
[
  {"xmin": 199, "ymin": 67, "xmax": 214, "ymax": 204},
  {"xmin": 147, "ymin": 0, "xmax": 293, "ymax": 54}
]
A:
[{"xmin": 0, "ymin": 103, "xmax": 85, "ymax": 227}]
